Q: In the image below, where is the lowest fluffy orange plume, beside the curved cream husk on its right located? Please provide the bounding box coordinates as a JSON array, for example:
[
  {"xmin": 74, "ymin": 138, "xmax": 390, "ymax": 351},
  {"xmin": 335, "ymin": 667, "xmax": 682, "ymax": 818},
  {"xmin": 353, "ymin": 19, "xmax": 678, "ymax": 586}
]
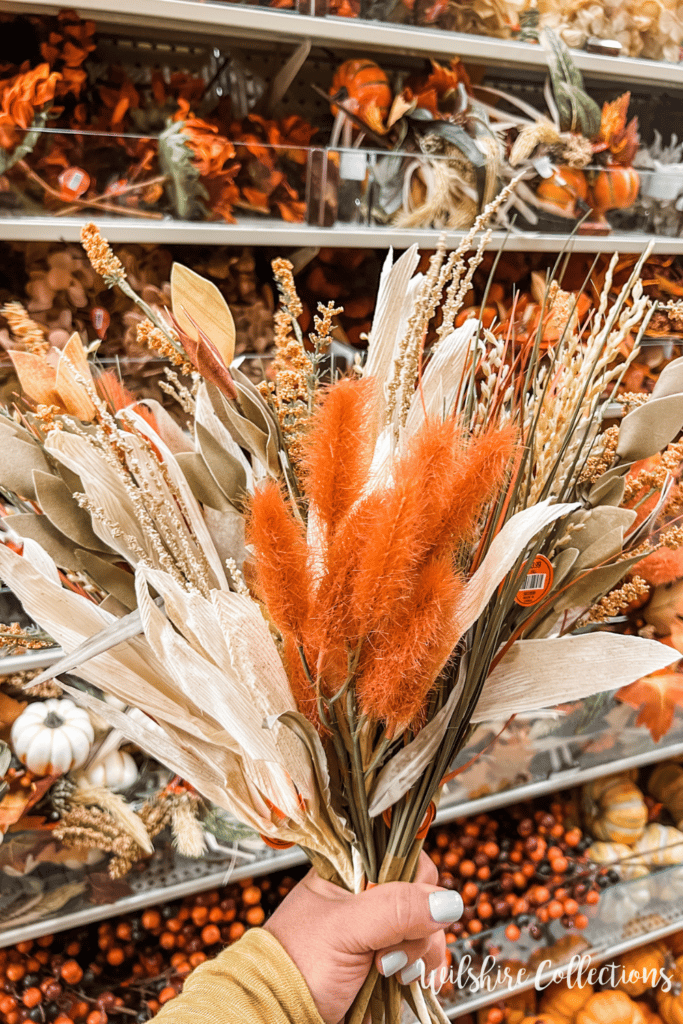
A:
[{"xmin": 356, "ymin": 556, "xmax": 463, "ymax": 727}]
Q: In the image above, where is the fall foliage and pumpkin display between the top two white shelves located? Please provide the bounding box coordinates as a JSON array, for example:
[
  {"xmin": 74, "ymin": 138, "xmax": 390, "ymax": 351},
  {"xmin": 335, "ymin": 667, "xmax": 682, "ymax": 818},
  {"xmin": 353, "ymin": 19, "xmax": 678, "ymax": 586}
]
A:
[{"xmin": 0, "ymin": 10, "xmax": 663, "ymax": 233}]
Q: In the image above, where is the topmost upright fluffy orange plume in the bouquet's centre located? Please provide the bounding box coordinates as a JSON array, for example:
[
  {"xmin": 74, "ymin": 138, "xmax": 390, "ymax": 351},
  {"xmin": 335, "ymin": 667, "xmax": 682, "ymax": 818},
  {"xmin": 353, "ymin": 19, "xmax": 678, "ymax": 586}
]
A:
[{"xmin": 302, "ymin": 378, "xmax": 377, "ymax": 535}]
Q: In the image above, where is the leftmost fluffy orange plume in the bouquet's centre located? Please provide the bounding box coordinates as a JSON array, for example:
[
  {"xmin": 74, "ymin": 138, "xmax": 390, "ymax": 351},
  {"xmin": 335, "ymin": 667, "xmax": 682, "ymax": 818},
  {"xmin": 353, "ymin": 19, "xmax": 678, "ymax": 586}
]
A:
[{"xmin": 247, "ymin": 480, "xmax": 310, "ymax": 642}]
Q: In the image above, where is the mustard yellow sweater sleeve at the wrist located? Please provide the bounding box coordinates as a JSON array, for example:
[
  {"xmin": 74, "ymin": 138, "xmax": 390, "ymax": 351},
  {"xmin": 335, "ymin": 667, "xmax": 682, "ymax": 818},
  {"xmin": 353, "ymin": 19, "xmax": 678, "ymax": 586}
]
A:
[{"xmin": 155, "ymin": 928, "xmax": 324, "ymax": 1024}]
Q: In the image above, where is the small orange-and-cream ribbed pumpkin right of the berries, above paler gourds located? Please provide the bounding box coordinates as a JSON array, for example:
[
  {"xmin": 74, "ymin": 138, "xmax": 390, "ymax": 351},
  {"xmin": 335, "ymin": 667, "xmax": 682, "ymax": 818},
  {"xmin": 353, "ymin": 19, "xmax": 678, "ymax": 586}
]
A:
[{"xmin": 583, "ymin": 775, "xmax": 647, "ymax": 845}]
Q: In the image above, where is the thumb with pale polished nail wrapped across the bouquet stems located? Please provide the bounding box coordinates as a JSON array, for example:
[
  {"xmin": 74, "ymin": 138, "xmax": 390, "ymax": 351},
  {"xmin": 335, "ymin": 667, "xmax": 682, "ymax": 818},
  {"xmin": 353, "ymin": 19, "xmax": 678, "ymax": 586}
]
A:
[{"xmin": 336, "ymin": 882, "xmax": 463, "ymax": 953}]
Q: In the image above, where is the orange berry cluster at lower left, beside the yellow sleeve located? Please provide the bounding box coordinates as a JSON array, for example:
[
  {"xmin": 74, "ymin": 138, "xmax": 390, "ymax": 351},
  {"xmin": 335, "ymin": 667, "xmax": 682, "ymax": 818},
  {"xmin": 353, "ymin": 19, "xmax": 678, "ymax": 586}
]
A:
[{"xmin": 0, "ymin": 877, "xmax": 295, "ymax": 1024}]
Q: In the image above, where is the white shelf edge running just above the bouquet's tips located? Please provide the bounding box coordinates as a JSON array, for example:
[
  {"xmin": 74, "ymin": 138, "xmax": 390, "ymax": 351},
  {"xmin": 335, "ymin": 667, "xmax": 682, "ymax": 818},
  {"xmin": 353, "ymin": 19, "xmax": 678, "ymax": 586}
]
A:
[{"xmin": 0, "ymin": 211, "xmax": 683, "ymax": 255}]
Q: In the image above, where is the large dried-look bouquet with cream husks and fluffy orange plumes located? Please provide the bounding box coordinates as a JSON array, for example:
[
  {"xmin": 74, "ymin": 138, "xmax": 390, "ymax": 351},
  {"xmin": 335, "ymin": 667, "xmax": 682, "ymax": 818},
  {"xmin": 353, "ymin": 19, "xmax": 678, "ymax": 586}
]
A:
[{"xmin": 0, "ymin": 210, "xmax": 683, "ymax": 1024}]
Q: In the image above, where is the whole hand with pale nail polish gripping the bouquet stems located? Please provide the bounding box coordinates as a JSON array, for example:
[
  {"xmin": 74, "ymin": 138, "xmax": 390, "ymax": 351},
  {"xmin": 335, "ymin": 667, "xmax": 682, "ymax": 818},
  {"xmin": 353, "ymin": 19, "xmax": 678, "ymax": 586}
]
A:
[{"xmin": 263, "ymin": 853, "xmax": 463, "ymax": 1024}]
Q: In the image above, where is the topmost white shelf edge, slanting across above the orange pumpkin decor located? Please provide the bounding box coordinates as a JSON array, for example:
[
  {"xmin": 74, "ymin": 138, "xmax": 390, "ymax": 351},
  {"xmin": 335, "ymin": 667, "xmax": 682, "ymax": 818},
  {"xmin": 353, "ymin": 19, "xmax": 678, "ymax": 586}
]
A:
[{"xmin": 5, "ymin": 0, "xmax": 683, "ymax": 90}]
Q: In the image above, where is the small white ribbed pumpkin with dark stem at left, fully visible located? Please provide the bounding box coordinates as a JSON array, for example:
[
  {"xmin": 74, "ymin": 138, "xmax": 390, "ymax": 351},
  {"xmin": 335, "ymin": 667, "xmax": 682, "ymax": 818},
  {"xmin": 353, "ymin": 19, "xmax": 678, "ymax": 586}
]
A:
[{"xmin": 10, "ymin": 697, "xmax": 95, "ymax": 775}]
